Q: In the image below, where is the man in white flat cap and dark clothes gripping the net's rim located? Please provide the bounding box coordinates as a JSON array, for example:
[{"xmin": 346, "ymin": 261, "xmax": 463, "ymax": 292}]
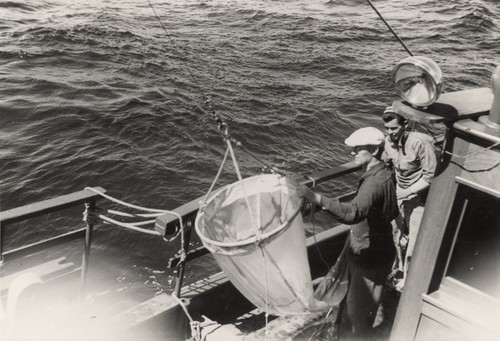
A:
[{"xmin": 298, "ymin": 127, "xmax": 399, "ymax": 339}]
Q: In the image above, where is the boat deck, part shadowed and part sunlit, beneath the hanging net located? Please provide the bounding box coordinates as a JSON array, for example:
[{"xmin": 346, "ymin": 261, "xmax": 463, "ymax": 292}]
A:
[{"xmin": 182, "ymin": 266, "xmax": 399, "ymax": 341}]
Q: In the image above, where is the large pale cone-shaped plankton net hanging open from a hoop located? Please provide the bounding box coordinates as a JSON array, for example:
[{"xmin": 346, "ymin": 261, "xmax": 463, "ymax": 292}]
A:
[{"xmin": 195, "ymin": 170, "xmax": 313, "ymax": 316}]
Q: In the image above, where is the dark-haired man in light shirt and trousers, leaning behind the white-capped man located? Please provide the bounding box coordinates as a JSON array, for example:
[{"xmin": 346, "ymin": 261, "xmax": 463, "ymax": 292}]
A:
[{"xmin": 382, "ymin": 107, "xmax": 437, "ymax": 291}]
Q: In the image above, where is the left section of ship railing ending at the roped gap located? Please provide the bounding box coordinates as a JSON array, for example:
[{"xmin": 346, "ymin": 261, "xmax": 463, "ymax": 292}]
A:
[{"xmin": 0, "ymin": 187, "xmax": 106, "ymax": 297}]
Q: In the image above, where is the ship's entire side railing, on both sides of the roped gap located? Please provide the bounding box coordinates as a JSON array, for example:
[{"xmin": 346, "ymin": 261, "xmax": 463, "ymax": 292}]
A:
[{"xmin": 0, "ymin": 133, "xmax": 443, "ymax": 297}]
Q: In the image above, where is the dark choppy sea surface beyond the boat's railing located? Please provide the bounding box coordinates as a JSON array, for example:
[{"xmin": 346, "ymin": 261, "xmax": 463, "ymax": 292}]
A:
[{"xmin": 0, "ymin": 0, "xmax": 500, "ymax": 308}]
